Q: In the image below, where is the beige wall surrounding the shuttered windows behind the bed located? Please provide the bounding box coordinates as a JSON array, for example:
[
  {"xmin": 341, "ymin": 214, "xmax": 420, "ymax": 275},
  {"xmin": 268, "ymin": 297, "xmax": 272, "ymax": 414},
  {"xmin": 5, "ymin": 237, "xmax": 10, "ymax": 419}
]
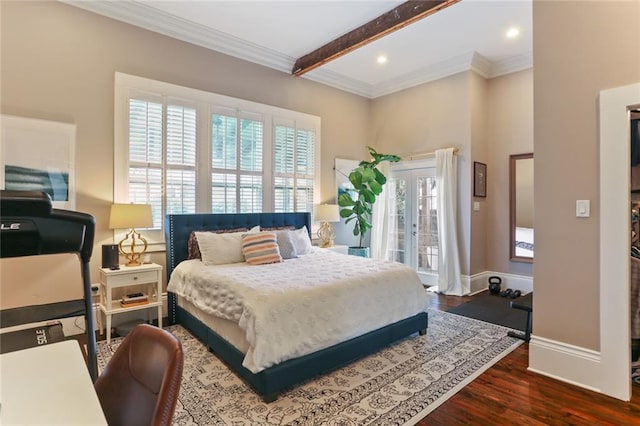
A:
[{"xmin": 0, "ymin": 1, "xmax": 370, "ymax": 308}]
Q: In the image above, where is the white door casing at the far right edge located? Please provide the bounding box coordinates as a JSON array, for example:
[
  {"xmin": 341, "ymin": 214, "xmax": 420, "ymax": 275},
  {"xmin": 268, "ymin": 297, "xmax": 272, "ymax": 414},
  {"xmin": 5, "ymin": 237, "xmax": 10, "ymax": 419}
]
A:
[{"xmin": 597, "ymin": 83, "xmax": 640, "ymax": 401}]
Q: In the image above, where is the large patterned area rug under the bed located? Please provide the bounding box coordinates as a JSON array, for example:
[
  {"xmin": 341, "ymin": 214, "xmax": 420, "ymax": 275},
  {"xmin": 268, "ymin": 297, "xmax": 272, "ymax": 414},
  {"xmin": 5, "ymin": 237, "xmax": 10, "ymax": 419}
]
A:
[{"xmin": 98, "ymin": 310, "xmax": 522, "ymax": 426}]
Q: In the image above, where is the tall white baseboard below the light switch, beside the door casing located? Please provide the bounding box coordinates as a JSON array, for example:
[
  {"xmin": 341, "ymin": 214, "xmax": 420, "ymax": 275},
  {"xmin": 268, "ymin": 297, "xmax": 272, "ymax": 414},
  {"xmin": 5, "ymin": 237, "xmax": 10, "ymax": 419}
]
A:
[{"xmin": 528, "ymin": 335, "xmax": 602, "ymax": 392}]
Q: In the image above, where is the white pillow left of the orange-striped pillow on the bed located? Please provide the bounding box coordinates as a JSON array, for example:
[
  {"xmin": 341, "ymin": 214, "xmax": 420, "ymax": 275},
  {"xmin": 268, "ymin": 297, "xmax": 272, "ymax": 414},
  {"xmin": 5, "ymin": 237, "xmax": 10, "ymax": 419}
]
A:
[{"xmin": 195, "ymin": 226, "xmax": 260, "ymax": 266}]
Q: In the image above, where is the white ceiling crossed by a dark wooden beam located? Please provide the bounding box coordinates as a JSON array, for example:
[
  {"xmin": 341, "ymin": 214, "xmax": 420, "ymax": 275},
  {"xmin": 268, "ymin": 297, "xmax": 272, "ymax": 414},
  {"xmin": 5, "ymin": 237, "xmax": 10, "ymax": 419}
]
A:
[{"xmin": 62, "ymin": 0, "xmax": 533, "ymax": 98}]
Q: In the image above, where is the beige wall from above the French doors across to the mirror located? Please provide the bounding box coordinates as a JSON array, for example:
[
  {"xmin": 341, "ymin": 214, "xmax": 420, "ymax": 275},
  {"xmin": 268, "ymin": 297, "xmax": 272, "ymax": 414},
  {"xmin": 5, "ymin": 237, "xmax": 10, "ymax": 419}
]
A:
[{"xmin": 371, "ymin": 69, "xmax": 533, "ymax": 276}]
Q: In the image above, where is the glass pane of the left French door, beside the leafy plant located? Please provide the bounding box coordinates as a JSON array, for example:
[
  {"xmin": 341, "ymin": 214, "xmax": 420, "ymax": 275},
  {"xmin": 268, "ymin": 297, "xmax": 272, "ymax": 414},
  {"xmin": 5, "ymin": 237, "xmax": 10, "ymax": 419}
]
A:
[{"xmin": 387, "ymin": 178, "xmax": 407, "ymax": 263}]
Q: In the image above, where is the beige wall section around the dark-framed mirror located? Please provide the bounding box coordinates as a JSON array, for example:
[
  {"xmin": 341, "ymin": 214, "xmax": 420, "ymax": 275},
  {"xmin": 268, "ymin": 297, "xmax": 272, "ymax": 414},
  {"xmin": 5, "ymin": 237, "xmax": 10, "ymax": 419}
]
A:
[{"xmin": 485, "ymin": 69, "xmax": 535, "ymax": 276}]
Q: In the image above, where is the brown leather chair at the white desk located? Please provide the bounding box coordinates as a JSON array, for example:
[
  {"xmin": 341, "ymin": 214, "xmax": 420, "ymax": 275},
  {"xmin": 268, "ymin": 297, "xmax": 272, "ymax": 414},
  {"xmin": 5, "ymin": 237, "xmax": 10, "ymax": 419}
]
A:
[{"xmin": 95, "ymin": 324, "xmax": 184, "ymax": 426}]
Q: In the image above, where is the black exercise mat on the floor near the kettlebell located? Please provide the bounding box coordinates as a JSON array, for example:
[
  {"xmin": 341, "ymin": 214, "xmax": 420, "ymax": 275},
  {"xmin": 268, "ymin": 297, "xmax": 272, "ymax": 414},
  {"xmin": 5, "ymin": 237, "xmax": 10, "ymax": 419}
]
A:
[{"xmin": 447, "ymin": 292, "xmax": 527, "ymax": 331}]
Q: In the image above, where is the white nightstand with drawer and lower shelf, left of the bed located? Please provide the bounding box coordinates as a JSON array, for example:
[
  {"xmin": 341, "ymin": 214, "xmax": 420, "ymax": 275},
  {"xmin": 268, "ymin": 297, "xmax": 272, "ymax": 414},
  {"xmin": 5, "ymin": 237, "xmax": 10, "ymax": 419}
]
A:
[{"xmin": 97, "ymin": 263, "xmax": 162, "ymax": 343}]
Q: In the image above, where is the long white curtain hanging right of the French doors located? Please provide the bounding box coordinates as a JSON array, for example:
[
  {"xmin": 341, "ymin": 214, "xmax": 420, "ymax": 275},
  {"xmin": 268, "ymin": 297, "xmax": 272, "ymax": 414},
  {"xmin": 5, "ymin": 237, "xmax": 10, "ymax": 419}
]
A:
[{"xmin": 436, "ymin": 148, "xmax": 462, "ymax": 296}]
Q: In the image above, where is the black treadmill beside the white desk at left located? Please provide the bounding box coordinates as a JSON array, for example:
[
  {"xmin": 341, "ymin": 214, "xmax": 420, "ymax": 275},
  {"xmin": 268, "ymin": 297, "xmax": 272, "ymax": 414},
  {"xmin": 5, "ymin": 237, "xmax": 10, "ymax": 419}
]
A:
[{"xmin": 0, "ymin": 190, "xmax": 98, "ymax": 382}]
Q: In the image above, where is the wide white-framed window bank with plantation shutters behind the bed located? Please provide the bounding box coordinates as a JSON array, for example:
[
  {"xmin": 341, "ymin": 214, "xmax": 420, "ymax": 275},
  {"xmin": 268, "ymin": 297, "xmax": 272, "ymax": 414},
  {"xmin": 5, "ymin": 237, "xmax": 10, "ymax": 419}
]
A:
[{"xmin": 114, "ymin": 73, "xmax": 320, "ymax": 241}]
